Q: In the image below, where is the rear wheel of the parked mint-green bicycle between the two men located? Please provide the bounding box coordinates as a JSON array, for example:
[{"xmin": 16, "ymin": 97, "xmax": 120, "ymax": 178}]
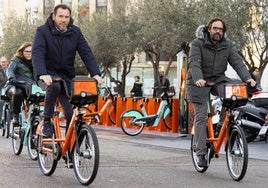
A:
[{"xmin": 121, "ymin": 109, "xmax": 144, "ymax": 136}]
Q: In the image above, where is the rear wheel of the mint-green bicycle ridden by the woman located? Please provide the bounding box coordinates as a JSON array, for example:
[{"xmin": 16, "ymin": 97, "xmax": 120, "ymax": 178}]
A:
[{"xmin": 11, "ymin": 127, "xmax": 24, "ymax": 155}]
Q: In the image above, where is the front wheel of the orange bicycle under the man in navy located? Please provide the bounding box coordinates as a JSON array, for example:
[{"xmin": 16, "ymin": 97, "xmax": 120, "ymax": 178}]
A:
[{"xmin": 72, "ymin": 124, "xmax": 100, "ymax": 185}]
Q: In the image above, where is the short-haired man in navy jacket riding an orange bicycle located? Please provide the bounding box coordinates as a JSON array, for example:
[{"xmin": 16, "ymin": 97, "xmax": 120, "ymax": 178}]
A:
[{"xmin": 32, "ymin": 4, "xmax": 103, "ymax": 137}]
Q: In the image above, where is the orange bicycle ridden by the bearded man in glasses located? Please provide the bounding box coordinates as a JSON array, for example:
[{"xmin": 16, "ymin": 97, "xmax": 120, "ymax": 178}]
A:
[{"xmin": 191, "ymin": 84, "xmax": 248, "ymax": 181}]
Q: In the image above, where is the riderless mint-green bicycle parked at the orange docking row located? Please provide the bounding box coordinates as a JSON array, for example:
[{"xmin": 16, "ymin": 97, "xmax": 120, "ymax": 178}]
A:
[{"xmin": 120, "ymin": 88, "xmax": 175, "ymax": 136}]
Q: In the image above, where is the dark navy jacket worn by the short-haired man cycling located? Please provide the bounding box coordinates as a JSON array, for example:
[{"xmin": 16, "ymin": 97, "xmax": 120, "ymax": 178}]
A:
[{"xmin": 32, "ymin": 14, "xmax": 100, "ymax": 89}]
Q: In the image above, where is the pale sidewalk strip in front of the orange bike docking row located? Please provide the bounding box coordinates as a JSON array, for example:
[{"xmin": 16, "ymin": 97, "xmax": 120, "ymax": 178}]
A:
[{"xmin": 93, "ymin": 126, "xmax": 268, "ymax": 160}]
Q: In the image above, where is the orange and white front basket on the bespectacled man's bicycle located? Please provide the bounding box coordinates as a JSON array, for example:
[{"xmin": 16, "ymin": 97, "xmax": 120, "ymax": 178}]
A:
[{"xmin": 222, "ymin": 84, "xmax": 248, "ymax": 108}]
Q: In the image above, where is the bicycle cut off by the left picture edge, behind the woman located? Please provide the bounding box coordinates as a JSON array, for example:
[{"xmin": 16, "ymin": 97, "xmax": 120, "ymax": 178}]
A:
[{"xmin": 0, "ymin": 89, "xmax": 11, "ymax": 138}]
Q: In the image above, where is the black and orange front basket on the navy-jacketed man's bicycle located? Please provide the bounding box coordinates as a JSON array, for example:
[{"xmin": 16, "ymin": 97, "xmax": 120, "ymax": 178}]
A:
[{"xmin": 70, "ymin": 76, "xmax": 98, "ymax": 105}]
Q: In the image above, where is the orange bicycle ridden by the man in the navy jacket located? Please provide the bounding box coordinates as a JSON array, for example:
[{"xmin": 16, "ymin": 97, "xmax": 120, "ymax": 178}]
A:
[{"xmin": 37, "ymin": 77, "xmax": 99, "ymax": 185}]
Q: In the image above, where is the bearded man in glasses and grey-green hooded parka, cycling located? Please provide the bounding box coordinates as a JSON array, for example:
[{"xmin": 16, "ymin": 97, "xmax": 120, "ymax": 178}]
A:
[{"xmin": 186, "ymin": 18, "xmax": 256, "ymax": 167}]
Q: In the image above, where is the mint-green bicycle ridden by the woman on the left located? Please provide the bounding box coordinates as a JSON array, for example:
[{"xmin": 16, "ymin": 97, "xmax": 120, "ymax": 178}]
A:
[{"xmin": 11, "ymin": 84, "xmax": 45, "ymax": 160}]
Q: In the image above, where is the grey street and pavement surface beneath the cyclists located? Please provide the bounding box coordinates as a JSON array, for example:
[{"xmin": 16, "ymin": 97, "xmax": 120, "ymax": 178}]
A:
[{"xmin": 0, "ymin": 127, "xmax": 268, "ymax": 188}]
